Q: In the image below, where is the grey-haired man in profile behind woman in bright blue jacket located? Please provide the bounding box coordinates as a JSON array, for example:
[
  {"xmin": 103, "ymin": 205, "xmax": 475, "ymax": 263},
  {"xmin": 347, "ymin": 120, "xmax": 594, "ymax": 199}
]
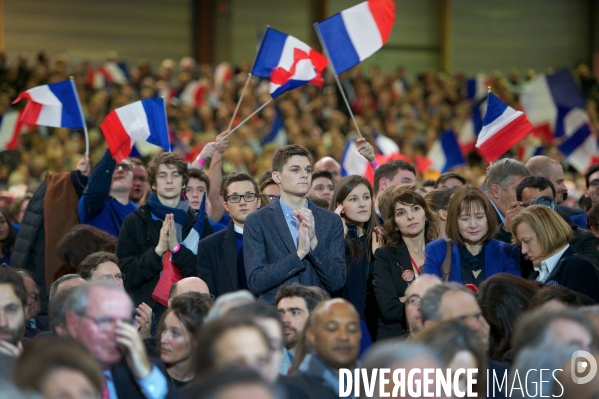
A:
[{"xmin": 485, "ymin": 158, "xmax": 530, "ymax": 224}]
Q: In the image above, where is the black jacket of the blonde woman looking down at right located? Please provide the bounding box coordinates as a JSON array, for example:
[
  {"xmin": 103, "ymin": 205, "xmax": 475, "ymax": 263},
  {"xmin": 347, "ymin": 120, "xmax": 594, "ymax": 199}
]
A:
[{"xmin": 529, "ymin": 246, "xmax": 599, "ymax": 302}]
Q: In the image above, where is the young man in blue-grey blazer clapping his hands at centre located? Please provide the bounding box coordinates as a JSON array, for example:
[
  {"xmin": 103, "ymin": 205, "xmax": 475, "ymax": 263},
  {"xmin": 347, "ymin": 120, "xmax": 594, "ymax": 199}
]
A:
[{"xmin": 243, "ymin": 145, "xmax": 346, "ymax": 304}]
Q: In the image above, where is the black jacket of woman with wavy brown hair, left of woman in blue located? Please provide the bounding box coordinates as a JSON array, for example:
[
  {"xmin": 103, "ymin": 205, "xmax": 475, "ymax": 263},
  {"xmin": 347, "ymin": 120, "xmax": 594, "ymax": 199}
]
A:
[{"xmin": 372, "ymin": 245, "xmax": 414, "ymax": 340}]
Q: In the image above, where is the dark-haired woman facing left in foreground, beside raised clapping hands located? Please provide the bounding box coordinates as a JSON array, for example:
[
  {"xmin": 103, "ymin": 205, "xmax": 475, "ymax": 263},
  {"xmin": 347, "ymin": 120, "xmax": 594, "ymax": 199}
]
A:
[{"xmin": 156, "ymin": 292, "xmax": 210, "ymax": 388}]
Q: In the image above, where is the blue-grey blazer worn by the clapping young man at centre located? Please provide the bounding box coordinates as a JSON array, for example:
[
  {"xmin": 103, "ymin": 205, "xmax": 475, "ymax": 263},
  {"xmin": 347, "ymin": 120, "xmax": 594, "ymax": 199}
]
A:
[{"xmin": 243, "ymin": 200, "xmax": 347, "ymax": 303}]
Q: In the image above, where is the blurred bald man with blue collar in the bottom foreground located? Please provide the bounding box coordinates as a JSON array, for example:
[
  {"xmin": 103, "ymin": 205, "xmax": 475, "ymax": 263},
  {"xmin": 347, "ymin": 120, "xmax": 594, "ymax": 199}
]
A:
[{"xmin": 286, "ymin": 298, "xmax": 362, "ymax": 398}]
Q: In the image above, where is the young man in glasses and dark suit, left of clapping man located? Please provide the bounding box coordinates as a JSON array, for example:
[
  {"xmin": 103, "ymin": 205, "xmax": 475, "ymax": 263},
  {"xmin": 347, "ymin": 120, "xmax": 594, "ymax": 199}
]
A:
[{"xmin": 198, "ymin": 173, "xmax": 260, "ymax": 297}]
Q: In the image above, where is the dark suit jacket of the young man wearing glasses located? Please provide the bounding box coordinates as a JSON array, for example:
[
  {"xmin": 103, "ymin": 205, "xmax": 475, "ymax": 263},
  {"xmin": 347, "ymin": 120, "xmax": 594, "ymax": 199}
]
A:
[{"xmin": 198, "ymin": 220, "xmax": 239, "ymax": 297}]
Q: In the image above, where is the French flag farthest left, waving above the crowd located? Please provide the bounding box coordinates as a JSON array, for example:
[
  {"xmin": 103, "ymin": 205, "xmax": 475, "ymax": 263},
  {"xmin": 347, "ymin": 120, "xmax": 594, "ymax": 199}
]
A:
[{"xmin": 13, "ymin": 80, "xmax": 84, "ymax": 129}]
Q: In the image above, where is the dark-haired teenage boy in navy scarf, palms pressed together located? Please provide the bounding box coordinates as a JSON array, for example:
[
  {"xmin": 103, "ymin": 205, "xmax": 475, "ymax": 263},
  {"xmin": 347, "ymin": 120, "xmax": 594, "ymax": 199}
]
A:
[{"xmin": 117, "ymin": 152, "xmax": 212, "ymax": 317}]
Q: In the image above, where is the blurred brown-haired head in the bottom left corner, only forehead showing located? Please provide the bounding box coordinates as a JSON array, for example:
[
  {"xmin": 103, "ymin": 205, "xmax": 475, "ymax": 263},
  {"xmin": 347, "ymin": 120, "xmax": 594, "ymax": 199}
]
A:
[{"xmin": 14, "ymin": 337, "xmax": 104, "ymax": 399}]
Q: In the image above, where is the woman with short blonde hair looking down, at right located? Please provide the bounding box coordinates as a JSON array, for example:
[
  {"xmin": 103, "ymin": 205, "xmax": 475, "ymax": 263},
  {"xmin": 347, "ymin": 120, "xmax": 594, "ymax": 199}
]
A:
[{"xmin": 511, "ymin": 205, "xmax": 599, "ymax": 301}]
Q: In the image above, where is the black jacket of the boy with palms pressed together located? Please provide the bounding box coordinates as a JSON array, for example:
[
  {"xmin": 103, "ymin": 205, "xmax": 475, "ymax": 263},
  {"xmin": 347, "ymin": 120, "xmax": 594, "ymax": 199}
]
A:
[{"xmin": 116, "ymin": 205, "xmax": 212, "ymax": 308}]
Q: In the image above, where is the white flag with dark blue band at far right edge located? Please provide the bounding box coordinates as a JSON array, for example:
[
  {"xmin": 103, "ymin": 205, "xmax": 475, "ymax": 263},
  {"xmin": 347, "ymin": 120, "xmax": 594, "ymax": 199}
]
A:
[{"xmin": 556, "ymin": 108, "xmax": 598, "ymax": 173}]
